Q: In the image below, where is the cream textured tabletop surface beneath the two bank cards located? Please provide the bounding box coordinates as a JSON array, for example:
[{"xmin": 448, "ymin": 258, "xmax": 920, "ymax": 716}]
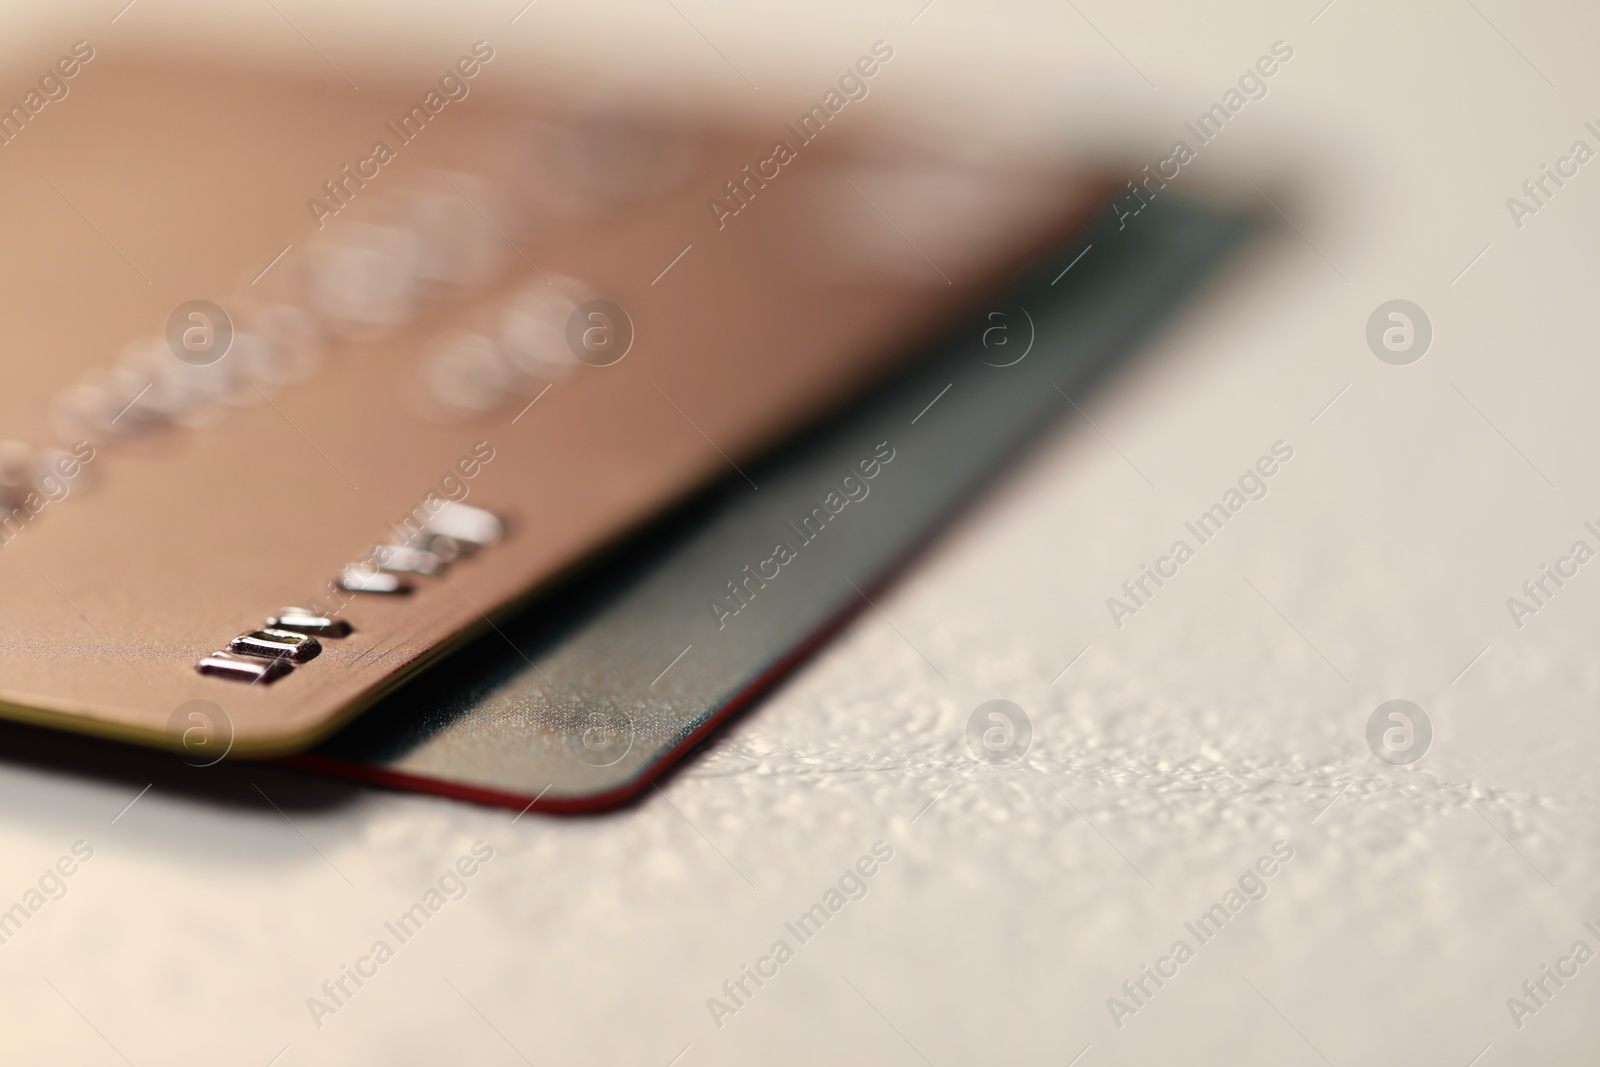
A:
[{"xmin": 0, "ymin": 0, "xmax": 1600, "ymax": 1067}]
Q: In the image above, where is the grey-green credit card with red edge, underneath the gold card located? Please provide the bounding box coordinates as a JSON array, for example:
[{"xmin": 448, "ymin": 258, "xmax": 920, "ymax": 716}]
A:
[{"xmin": 300, "ymin": 202, "xmax": 1246, "ymax": 811}]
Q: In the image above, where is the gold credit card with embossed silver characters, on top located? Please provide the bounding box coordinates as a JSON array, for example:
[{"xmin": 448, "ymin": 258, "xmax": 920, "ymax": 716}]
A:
[{"xmin": 0, "ymin": 42, "xmax": 1098, "ymax": 755}]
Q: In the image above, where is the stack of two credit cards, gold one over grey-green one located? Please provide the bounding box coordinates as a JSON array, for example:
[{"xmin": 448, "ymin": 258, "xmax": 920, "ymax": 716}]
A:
[{"xmin": 0, "ymin": 42, "xmax": 1240, "ymax": 809}]
